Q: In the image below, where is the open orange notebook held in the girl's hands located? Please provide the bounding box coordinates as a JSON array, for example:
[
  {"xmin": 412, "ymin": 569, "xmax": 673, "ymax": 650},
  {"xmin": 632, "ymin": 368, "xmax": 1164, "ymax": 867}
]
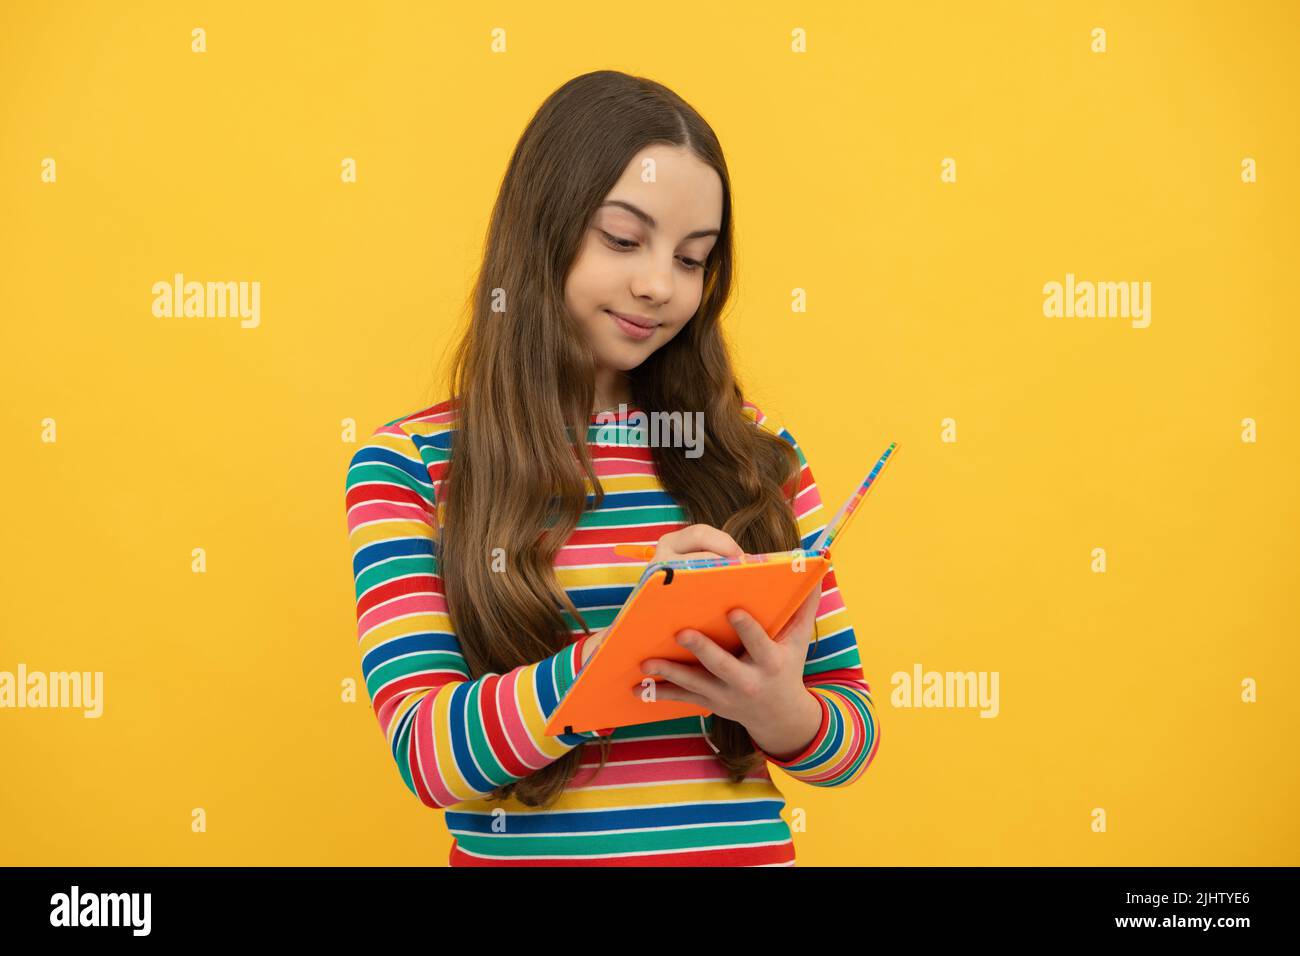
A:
[{"xmin": 546, "ymin": 442, "xmax": 898, "ymax": 736}]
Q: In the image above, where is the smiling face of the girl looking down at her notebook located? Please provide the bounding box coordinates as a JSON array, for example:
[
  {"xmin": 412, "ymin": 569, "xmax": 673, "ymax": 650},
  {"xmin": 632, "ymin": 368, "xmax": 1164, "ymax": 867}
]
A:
[{"xmin": 564, "ymin": 146, "xmax": 723, "ymax": 380}]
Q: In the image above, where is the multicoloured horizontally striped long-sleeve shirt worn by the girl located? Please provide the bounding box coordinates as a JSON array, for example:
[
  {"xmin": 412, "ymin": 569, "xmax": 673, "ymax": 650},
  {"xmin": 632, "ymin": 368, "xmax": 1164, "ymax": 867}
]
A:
[{"xmin": 346, "ymin": 401, "xmax": 880, "ymax": 866}]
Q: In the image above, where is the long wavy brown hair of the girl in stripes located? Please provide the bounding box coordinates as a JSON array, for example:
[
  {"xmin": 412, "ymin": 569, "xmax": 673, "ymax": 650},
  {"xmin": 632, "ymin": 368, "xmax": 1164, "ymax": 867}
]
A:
[{"xmin": 438, "ymin": 70, "xmax": 800, "ymax": 806}]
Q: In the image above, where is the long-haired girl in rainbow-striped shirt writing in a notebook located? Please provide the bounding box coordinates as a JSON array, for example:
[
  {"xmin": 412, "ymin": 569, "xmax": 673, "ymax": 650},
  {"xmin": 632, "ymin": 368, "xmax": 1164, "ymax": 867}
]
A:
[{"xmin": 347, "ymin": 70, "xmax": 880, "ymax": 866}]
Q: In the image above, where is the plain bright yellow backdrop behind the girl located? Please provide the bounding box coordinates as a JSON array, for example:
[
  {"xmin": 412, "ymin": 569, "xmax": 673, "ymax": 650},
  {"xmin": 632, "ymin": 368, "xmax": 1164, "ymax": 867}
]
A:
[{"xmin": 0, "ymin": 1, "xmax": 1300, "ymax": 865}]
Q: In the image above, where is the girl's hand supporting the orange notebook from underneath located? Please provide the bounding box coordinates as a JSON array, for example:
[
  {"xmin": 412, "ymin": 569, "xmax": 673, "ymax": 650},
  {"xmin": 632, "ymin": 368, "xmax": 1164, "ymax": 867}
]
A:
[{"xmin": 633, "ymin": 584, "xmax": 822, "ymax": 735}]
